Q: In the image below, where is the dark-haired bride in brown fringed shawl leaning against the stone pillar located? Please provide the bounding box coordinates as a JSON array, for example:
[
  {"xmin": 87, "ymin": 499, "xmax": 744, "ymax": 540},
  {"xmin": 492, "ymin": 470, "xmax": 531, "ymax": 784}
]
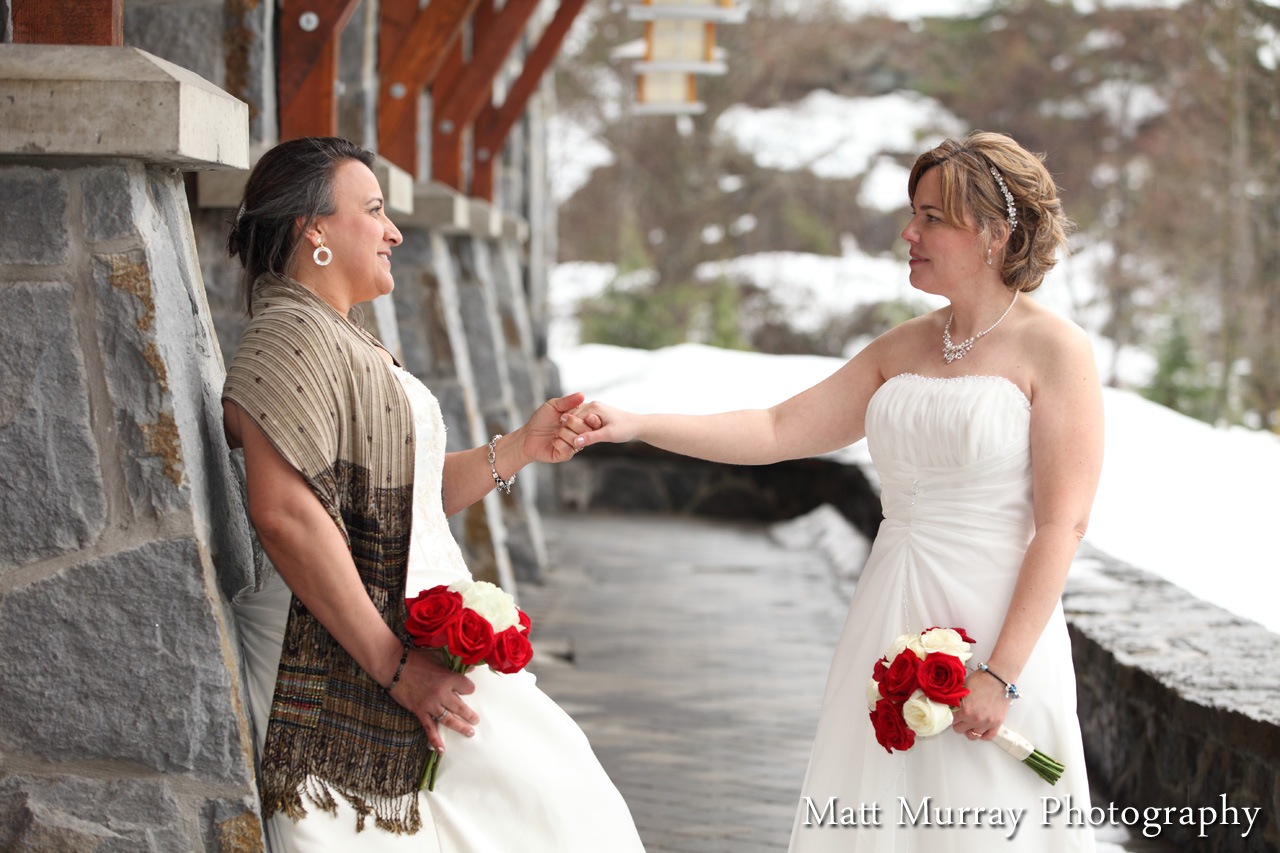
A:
[{"xmin": 223, "ymin": 138, "xmax": 643, "ymax": 853}]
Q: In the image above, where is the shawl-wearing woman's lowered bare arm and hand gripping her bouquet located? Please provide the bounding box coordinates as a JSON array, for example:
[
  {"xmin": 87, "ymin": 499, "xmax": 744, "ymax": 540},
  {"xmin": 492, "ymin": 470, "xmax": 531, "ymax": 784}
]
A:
[{"xmin": 223, "ymin": 402, "xmax": 479, "ymax": 751}]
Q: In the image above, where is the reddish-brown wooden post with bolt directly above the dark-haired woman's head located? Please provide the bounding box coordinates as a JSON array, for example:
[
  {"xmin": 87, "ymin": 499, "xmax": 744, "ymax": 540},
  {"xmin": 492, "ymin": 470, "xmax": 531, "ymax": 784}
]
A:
[{"xmin": 278, "ymin": 0, "xmax": 360, "ymax": 141}]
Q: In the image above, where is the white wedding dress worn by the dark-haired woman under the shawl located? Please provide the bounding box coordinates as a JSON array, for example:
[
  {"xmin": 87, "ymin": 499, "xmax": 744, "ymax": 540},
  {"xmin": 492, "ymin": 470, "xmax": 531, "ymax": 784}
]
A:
[{"xmin": 234, "ymin": 368, "xmax": 644, "ymax": 853}]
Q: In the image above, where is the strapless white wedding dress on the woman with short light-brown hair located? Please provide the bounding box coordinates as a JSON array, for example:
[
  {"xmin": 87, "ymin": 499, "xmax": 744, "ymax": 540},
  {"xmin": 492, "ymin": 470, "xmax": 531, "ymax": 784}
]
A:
[{"xmin": 790, "ymin": 374, "xmax": 1093, "ymax": 853}]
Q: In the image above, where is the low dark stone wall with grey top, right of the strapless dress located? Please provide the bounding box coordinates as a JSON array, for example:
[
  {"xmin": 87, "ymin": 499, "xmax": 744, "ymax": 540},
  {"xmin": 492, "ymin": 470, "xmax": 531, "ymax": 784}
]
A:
[{"xmin": 1062, "ymin": 543, "xmax": 1280, "ymax": 853}]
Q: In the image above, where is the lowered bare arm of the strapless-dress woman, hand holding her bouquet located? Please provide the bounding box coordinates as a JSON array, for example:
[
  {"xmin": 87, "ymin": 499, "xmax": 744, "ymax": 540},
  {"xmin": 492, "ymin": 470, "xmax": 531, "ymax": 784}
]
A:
[{"xmin": 955, "ymin": 322, "xmax": 1103, "ymax": 735}]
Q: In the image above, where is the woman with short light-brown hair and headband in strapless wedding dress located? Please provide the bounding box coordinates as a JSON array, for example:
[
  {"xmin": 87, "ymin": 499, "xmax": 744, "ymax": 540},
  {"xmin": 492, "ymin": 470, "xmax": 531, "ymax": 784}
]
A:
[{"xmin": 563, "ymin": 133, "xmax": 1102, "ymax": 853}]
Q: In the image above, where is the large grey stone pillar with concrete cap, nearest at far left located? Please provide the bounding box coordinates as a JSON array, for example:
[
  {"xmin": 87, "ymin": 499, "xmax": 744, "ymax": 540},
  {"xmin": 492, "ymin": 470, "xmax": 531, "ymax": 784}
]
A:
[{"xmin": 0, "ymin": 45, "xmax": 264, "ymax": 853}]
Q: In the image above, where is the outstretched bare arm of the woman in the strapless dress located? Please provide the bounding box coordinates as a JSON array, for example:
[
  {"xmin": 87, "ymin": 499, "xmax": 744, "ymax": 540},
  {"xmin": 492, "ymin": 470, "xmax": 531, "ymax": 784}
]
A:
[{"xmin": 570, "ymin": 338, "xmax": 884, "ymax": 465}]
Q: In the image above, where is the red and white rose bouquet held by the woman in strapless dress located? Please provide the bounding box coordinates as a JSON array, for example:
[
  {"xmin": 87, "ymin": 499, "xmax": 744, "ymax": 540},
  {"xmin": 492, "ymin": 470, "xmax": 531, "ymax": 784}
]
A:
[{"xmin": 867, "ymin": 628, "xmax": 1064, "ymax": 785}]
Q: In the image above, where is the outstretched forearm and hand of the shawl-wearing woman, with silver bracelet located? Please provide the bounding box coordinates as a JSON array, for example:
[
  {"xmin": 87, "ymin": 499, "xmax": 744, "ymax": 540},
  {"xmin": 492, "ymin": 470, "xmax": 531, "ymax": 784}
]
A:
[{"xmin": 443, "ymin": 393, "xmax": 582, "ymax": 516}]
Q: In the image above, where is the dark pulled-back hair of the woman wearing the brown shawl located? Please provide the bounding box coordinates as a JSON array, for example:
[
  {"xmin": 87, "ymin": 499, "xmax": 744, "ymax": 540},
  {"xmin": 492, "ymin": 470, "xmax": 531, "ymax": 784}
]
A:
[{"xmin": 227, "ymin": 136, "xmax": 374, "ymax": 315}]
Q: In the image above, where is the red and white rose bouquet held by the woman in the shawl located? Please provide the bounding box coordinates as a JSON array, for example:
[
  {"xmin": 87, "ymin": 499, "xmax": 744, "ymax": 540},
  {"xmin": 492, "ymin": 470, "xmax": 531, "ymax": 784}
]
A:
[{"xmin": 404, "ymin": 580, "xmax": 534, "ymax": 790}]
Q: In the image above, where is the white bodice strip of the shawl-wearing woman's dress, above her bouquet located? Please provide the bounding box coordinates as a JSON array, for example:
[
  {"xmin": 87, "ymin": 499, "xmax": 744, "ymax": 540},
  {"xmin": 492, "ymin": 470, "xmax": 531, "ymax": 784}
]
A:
[{"xmin": 392, "ymin": 366, "xmax": 471, "ymax": 597}]
